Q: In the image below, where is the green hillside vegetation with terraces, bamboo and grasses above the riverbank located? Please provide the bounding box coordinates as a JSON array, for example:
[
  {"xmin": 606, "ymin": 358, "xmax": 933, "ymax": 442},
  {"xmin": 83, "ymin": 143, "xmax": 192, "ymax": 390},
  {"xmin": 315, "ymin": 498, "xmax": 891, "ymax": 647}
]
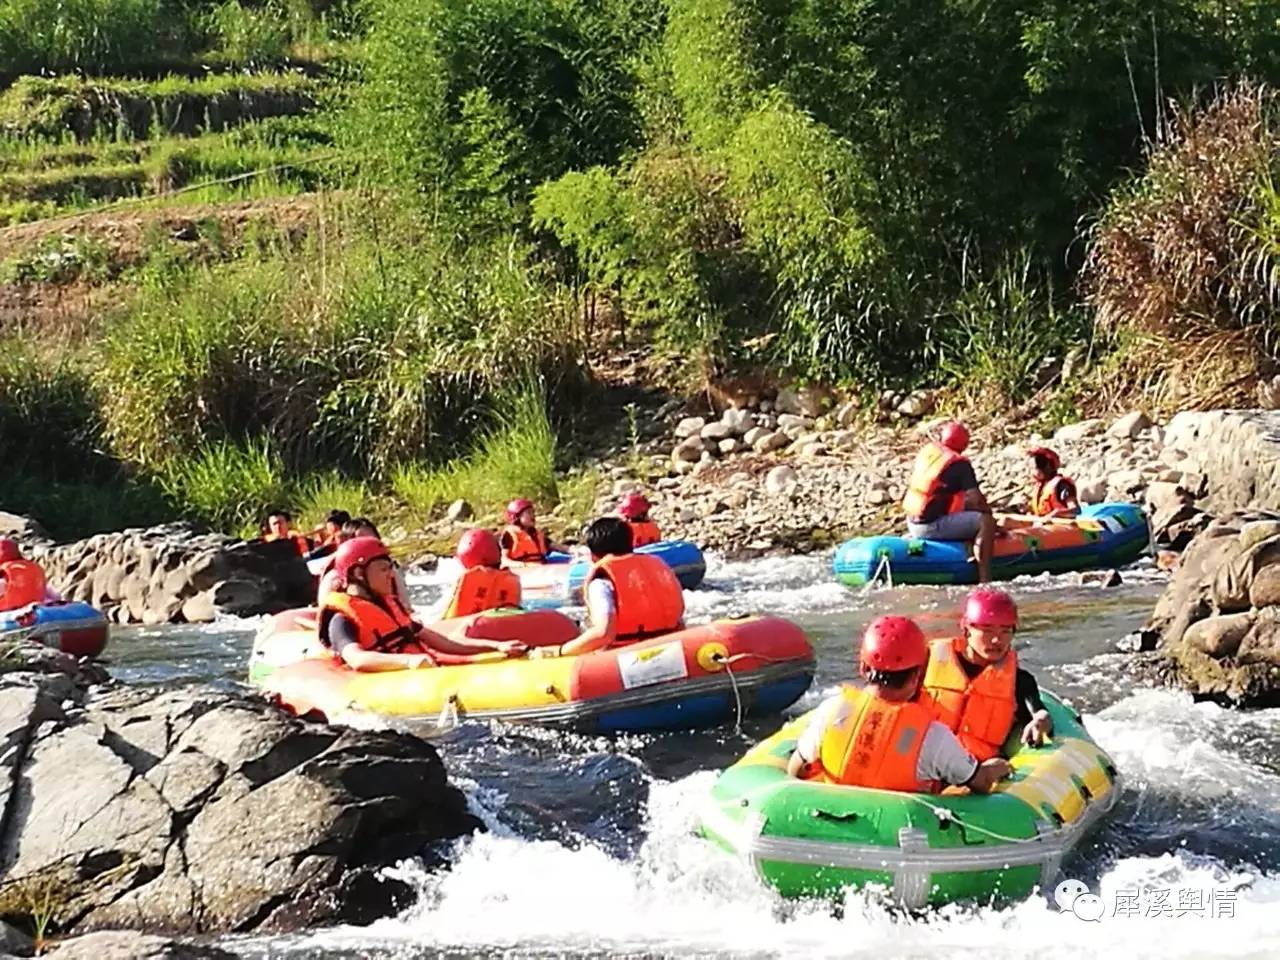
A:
[{"xmin": 0, "ymin": 0, "xmax": 1280, "ymax": 542}]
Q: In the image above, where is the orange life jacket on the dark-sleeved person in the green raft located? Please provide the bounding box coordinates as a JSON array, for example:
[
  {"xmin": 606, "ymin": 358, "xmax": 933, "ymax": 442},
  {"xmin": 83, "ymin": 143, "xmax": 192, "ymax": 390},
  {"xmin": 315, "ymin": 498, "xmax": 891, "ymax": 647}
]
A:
[{"xmin": 924, "ymin": 636, "xmax": 1018, "ymax": 762}]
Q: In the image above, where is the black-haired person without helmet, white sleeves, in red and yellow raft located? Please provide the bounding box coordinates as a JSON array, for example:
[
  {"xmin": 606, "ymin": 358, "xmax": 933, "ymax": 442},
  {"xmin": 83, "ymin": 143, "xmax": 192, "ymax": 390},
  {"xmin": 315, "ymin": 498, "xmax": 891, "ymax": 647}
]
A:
[{"xmin": 530, "ymin": 517, "xmax": 685, "ymax": 657}]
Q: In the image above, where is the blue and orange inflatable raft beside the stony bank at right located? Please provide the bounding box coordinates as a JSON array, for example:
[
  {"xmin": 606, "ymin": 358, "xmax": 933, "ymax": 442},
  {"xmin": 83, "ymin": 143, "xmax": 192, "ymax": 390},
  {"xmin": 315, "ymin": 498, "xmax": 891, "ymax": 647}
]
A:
[{"xmin": 832, "ymin": 503, "xmax": 1148, "ymax": 586}]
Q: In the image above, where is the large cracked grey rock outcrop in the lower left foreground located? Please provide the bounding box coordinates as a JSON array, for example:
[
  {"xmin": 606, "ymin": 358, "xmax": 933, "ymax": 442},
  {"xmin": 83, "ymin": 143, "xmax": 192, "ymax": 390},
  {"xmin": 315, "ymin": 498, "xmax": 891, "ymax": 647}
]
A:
[{"xmin": 0, "ymin": 648, "xmax": 479, "ymax": 952}]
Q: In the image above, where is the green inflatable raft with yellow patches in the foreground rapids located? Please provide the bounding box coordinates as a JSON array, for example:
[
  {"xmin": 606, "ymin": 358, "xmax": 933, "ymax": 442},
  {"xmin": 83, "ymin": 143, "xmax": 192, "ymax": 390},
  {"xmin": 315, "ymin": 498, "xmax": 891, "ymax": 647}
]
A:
[{"xmin": 701, "ymin": 692, "xmax": 1120, "ymax": 908}]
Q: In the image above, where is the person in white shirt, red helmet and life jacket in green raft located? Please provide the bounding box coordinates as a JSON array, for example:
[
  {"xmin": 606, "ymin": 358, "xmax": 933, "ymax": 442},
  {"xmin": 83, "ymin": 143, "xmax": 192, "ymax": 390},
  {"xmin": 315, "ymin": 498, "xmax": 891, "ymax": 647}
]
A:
[{"xmin": 787, "ymin": 617, "xmax": 1010, "ymax": 794}]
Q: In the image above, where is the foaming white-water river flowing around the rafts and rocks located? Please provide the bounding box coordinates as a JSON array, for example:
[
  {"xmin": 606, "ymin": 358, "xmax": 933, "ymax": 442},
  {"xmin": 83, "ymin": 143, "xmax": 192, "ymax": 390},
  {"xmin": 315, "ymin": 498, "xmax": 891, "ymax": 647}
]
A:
[{"xmin": 104, "ymin": 557, "xmax": 1280, "ymax": 960}]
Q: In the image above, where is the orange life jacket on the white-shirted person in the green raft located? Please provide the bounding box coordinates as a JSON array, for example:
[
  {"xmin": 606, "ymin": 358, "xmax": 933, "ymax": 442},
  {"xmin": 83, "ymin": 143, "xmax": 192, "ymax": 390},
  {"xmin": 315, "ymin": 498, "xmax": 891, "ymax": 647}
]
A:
[{"xmin": 805, "ymin": 687, "xmax": 937, "ymax": 794}]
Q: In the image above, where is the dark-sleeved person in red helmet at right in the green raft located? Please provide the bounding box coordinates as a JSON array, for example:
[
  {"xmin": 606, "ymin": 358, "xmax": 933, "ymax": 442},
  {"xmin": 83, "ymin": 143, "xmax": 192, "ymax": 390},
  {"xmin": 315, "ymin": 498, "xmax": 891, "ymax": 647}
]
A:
[{"xmin": 924, "ymin": 588, "xmax": 1053, "ymax": 760}]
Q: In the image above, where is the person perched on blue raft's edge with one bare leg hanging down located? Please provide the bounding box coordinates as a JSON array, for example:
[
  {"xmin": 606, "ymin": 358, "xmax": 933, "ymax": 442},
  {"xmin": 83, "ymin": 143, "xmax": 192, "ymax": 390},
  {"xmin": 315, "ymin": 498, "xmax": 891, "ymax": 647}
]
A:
[{"xmin": 902, "ymin": 420, "xmax": 996, "ymax": 582}]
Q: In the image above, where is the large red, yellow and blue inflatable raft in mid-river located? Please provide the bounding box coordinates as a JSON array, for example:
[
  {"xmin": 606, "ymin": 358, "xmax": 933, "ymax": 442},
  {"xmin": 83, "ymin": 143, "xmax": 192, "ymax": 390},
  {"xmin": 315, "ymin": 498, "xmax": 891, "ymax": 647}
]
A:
[{"xmin": 250, "ymin": 611, "xmax": 814, "ymax": 732}]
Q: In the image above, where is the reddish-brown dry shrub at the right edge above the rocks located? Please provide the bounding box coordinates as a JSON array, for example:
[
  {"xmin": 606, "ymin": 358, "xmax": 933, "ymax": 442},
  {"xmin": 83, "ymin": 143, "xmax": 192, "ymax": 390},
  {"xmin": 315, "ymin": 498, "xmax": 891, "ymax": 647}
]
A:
[{"xmin": 1083, "ymin": 84, "xmax": 1280, "ymax": 345}]
